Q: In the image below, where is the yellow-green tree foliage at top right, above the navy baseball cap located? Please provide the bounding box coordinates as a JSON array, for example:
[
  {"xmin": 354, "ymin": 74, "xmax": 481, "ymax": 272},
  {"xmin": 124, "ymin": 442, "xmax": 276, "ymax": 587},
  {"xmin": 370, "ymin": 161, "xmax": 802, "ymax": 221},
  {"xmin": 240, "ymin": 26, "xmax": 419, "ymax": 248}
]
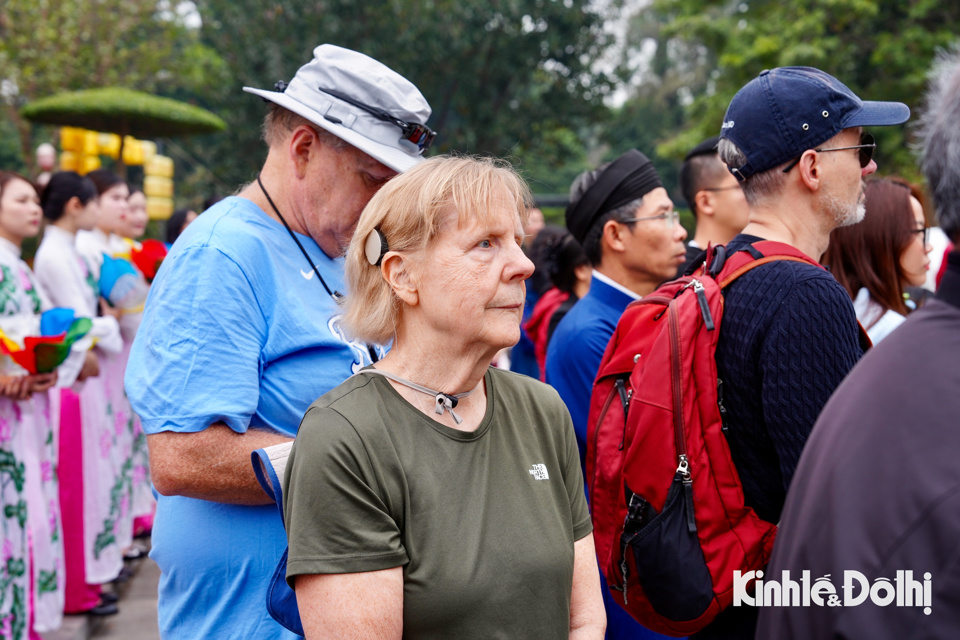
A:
[{"xmin": 620, "ymin": 0, "xmax": 960, "ymax": 185}]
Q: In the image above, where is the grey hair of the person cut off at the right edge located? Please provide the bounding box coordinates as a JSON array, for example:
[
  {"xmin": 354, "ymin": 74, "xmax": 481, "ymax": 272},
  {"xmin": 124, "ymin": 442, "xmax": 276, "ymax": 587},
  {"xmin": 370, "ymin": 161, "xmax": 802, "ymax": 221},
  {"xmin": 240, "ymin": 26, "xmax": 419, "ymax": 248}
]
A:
[{"xmin": 917, "ymin": 45, "xmax": 960, "ymax": 242}]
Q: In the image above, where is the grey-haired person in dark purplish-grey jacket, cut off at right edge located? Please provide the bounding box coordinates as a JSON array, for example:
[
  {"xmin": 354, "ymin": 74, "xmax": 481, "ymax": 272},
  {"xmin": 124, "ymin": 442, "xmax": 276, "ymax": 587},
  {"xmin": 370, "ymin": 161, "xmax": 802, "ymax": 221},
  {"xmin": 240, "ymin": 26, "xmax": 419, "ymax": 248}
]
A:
[{"xmin": 757, "ymin": 49, "xmax": 960, "ymax": 640}]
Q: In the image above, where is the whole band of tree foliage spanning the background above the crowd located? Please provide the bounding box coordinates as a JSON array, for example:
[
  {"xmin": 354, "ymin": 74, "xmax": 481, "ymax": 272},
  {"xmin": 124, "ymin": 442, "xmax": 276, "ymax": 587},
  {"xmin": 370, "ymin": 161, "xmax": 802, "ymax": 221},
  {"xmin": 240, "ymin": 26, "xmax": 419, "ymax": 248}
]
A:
[{"xmin": 0, "ymin": 0, "xmax": 960, "ymax": 204}]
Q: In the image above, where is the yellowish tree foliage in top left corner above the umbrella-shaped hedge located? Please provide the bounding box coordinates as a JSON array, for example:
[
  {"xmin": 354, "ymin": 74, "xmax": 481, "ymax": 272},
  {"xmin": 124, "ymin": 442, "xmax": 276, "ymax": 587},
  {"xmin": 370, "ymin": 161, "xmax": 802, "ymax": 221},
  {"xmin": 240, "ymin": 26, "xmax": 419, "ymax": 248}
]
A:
[{"xmin": 0, "ymin": 0, "xmax": 224, "ymax": 170}]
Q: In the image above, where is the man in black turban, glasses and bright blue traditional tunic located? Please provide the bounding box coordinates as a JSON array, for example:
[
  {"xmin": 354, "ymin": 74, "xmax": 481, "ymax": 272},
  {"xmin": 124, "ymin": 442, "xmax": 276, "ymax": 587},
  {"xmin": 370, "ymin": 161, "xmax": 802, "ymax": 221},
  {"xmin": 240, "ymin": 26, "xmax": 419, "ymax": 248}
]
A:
[{"xmin": 547, "ymin": 150, "xmax": 687, "ymax": 640}]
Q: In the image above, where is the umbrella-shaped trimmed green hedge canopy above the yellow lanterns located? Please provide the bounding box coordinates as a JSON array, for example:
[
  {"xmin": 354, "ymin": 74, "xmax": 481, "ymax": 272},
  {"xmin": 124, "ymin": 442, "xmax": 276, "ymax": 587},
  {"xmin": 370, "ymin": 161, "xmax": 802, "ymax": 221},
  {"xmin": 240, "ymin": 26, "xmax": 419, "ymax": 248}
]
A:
[{"xmin": 20, "ymin": 87, "xmax": 227, "ymax": 138}]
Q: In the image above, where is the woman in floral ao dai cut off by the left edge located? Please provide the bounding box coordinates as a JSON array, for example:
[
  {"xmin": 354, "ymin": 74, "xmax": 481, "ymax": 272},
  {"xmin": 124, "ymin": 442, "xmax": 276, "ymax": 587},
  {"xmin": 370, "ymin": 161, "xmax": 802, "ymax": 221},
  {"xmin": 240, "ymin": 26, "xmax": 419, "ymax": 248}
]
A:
[{"xmin": 0, "ymin": 172, "xmax": 84, "ymax": 638}]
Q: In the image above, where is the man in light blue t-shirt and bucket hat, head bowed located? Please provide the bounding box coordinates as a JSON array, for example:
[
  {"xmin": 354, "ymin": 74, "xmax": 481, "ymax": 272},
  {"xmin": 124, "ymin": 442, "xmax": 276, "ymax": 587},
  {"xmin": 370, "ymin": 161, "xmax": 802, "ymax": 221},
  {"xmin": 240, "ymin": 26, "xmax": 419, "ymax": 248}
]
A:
[{"xmin": 126, "ymin": 45, "xmax": 433, "ymax": 640}]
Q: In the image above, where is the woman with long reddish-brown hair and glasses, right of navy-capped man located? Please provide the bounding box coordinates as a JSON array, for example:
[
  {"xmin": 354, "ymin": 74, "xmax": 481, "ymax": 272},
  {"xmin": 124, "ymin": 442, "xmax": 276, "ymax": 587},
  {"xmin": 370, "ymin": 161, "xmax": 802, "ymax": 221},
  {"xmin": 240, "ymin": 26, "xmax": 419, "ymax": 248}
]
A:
[{"xmin": 822, "ymin": 179, "xmax": 931, "ymax": 344}]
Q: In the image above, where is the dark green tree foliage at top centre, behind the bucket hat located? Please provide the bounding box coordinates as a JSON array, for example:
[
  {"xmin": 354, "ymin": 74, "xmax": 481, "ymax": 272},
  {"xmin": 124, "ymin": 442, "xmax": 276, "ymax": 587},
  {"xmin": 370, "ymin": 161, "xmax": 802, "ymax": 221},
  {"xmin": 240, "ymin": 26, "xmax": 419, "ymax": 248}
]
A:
[{"xmin": 174, "ymin": 0, "xmax": 615, "ymax": 198}]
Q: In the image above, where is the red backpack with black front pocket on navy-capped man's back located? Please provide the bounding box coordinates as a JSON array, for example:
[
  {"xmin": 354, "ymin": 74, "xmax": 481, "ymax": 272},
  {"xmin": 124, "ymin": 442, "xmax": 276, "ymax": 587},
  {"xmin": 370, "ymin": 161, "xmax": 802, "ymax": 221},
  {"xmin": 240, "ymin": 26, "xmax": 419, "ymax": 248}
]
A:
[{"xmin": 586, "ymin": 241, "xmax": 819, "ymax": 636}]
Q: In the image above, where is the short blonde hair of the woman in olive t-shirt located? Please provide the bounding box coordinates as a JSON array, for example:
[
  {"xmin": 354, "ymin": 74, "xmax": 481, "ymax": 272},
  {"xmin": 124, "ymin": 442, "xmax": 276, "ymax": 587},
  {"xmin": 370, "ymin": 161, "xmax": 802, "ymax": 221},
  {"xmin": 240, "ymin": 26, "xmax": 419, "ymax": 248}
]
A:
[{"xmin": 343, "ymin": 156, "xmax": 532, "ymax": 344}]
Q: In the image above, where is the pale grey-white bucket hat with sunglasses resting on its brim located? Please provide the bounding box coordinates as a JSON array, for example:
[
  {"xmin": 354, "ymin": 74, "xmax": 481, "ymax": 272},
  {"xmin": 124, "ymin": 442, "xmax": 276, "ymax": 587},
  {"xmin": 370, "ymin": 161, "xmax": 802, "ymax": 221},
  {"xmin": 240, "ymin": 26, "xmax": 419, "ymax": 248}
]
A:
[{"xmin": 243, "ymin": 44, "xmax": 436, "ymax": 172}]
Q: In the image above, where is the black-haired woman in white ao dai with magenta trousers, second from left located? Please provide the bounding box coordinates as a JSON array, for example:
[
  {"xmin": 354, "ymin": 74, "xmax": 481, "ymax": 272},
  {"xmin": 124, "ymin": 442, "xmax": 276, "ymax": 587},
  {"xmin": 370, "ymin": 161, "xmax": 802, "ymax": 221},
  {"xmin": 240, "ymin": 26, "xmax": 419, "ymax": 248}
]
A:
[{"xmin": 34, "ymin": 171, "xmax": 123, "ymax": 613}]
